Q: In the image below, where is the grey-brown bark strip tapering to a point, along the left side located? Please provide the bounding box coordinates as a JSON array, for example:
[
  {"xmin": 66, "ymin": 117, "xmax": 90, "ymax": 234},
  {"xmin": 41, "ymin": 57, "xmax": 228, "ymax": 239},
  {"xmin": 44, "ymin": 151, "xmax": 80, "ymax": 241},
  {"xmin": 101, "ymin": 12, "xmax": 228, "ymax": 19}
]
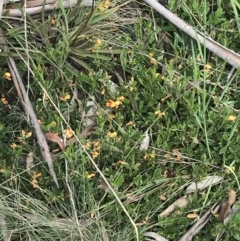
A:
[{"xmin": 0, "ymin": 29, "xmax": 59, "ymax": 187}]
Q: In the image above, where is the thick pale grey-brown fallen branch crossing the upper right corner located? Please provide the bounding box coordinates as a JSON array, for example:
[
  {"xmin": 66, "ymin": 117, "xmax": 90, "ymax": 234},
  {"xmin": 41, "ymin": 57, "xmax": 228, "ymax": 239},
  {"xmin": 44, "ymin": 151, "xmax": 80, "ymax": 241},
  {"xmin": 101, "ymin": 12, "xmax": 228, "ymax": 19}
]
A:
[{"xmin": 144, "ymin": 0, "xmax": 240, "ymax": 69}]
